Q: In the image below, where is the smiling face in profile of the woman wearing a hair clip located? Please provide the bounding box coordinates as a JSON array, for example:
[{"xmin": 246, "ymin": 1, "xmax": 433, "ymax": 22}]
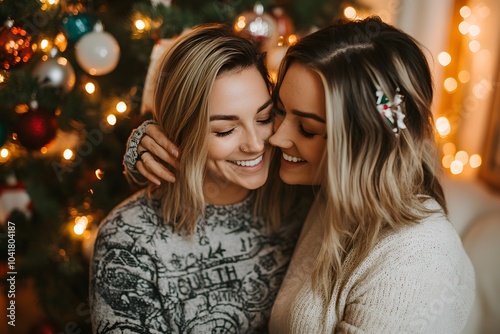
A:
[{"xmin": 269, "ymin": 63, "xmax": 326, "ymax": 185}]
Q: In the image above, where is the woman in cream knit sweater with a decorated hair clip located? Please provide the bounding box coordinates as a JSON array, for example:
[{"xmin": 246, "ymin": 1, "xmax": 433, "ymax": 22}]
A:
[{"xmin": 124, "ymin": 17, "xmax": 474, "ymax": 333}]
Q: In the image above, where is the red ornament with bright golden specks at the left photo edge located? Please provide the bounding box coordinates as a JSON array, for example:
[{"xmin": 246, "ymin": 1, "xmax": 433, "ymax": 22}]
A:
[{"xmin": 0, "ymin": 20, "xmax": 33, "ymax": 70}]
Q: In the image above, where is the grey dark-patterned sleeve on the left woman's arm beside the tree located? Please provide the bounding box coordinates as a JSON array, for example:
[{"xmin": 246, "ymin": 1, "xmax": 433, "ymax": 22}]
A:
[{"xmin": 89, "ymin": 198, "xmax": 168, "ymax": 333}]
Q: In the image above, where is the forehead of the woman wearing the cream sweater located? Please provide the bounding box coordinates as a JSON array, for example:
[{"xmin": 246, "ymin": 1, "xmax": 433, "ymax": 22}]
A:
[{"xmin": 279, "ymin": 62, "xmax": 326, "ymax": 118}]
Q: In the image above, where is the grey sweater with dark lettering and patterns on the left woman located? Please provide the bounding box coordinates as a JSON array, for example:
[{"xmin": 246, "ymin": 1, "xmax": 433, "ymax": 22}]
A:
[{"xmin": 90, "ymin": 191, "xmax": 307, "ymax": 333}]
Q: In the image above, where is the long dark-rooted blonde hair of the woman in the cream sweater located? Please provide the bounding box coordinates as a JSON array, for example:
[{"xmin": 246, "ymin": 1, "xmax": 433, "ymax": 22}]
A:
[{"xmin": 275, "ymin": 17, "xmax": 446, "ymax": 300}]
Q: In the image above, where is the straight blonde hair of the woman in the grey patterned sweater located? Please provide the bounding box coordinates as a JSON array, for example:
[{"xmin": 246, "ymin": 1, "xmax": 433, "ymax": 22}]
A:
[{"xmin": 150, "ymin": 24, "xmax": 286, "ymax": 234}]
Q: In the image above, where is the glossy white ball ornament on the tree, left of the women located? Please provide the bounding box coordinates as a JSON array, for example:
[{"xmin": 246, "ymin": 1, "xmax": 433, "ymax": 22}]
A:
[{"xmin": 75, "ymin": 22, "xmax": 120, "ymax": 75}]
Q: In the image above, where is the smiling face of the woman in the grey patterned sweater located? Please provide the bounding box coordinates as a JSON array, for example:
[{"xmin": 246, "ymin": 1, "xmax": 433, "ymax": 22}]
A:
[{"xmin": 204, "ymin": 67, "xmax": 273, "ymax": 204}]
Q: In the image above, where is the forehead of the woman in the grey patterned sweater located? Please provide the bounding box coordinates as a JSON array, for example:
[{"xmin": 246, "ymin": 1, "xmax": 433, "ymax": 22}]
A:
[{"xmin": 210, "ymin": 67, "xmax": 270, "ymax": 115}]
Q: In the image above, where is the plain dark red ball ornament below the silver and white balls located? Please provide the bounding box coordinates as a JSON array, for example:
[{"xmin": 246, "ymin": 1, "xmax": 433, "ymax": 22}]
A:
[{"xmin": 17, "ymin": 109, "xmax": 57, "ymax": 150}]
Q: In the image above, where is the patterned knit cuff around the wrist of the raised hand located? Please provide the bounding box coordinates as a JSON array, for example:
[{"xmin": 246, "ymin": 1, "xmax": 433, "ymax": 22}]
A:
[{"xmin": 123, "ymin": 120, "xmax": 155, "ymax": 186}]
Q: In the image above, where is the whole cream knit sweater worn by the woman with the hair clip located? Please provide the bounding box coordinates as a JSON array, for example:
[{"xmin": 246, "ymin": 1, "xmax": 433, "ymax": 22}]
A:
[{"xmin": 270, "ymin": 200, "xmax": 475, "ymax": 334}]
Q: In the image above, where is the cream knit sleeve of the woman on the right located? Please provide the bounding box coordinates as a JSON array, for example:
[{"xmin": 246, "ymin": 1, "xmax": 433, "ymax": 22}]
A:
[{"xmin": 336, "ymin": 218, "xmax": 474, "ymax": 333}]
